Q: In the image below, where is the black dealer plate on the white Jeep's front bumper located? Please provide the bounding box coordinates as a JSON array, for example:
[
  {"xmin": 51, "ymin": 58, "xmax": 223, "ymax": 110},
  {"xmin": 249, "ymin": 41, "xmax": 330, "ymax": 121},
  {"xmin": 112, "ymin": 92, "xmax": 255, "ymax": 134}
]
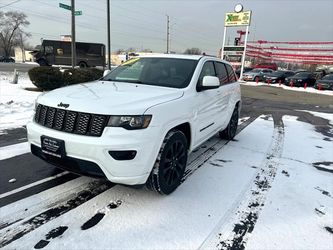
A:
[{"xmin": 40, "ymin": 135, "xmax": 66, "ymax": 158}]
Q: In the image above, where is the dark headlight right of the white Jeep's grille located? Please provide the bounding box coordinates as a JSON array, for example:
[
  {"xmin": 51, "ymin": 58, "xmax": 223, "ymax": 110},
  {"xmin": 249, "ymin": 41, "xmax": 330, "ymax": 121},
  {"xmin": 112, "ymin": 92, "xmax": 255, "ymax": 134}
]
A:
[{"xmin": 107, "ymin": 115, "xmax": 152, "ymax": 130}]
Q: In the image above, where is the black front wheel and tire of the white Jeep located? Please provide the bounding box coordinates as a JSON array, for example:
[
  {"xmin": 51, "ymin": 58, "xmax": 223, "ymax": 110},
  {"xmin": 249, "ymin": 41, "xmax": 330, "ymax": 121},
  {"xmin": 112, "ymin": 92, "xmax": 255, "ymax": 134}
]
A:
[{"xmin": 146, "ymin": 130, "xmax": 187, "ymax": 194}]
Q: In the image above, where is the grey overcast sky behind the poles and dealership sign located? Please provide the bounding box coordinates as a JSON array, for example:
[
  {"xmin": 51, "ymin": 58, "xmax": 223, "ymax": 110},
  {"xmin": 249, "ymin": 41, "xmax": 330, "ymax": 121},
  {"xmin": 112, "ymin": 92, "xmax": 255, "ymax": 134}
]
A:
[{"xmin": 0, "ymin": 0, "xmax": 333, "ymax": 55}]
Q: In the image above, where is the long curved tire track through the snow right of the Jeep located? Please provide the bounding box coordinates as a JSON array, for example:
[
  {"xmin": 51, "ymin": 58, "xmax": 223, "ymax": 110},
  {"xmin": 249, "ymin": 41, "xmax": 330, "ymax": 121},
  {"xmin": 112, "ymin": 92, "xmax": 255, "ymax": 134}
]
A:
[{"xmin": 201, "ymin": 116, "xmax": 284, "ymax": 250}]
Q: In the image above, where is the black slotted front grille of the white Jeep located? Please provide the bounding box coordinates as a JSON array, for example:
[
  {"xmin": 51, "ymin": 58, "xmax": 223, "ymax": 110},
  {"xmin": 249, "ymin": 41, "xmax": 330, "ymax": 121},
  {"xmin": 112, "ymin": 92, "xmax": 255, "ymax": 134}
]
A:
[{"xmin": 34, "ymin": 104, "xmax": 109, "ymax": 136}]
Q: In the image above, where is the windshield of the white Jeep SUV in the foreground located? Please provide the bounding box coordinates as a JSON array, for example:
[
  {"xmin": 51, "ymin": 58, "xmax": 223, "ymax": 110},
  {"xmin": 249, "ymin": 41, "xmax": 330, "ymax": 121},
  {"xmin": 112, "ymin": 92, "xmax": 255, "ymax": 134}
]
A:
[{"xmin": 101, "ymin": 58, "xmax": 198, "ymax": 88}]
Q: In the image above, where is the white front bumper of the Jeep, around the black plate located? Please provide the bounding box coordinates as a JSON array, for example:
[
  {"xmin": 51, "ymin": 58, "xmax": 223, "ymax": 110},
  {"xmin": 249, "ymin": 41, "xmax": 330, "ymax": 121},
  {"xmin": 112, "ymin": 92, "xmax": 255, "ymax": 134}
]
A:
[{"xmin": 27, "ymin": 122, "xmax": 163, "ymax": 185}]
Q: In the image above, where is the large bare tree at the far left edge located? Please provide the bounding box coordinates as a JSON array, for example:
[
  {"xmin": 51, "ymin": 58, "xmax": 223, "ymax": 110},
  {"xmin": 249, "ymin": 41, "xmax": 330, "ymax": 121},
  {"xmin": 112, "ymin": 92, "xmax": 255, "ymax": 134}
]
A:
[{"xmin": 0, "ymin": 11, "xmax": 30, "ymax": 56}]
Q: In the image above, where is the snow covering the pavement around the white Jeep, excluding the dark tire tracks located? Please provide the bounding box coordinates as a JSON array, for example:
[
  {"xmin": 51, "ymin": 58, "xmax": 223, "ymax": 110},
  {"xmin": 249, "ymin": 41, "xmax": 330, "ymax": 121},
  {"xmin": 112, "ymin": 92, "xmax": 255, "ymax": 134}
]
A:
[{"xmin": 0, "ymin": 116, "xmax": 333, "ymax": 249}]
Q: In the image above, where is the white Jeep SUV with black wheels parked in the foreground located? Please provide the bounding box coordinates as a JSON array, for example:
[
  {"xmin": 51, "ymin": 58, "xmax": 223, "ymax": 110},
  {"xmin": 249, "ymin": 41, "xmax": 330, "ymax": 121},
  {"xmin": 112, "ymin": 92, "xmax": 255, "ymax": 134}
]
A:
[{"xmin": 27, "ymin": 55, "xmax": 241, "ymax": 194}]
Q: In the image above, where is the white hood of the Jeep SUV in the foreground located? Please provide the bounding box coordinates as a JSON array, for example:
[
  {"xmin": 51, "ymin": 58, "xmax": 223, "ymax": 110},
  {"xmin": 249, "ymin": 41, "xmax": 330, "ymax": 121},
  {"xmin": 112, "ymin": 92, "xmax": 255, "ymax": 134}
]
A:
[{"xmin": 37, "ymin": 81, "xmax": 184, "ymax": 115}]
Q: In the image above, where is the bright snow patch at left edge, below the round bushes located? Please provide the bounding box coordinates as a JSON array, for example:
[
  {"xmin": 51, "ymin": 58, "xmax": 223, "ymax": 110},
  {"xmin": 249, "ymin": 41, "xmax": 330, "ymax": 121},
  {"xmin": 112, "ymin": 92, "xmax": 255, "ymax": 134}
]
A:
[{"xmin": 0, "ymin": 72, "xmax": 40, "ymax": 134}]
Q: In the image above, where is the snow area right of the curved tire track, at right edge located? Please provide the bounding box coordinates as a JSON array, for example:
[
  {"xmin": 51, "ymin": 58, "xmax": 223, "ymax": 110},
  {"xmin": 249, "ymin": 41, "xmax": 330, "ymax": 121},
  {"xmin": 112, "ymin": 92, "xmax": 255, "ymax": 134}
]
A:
[{"xmin": 247, "ymin": 116, "xmax": 333, "ymax": 249}]
